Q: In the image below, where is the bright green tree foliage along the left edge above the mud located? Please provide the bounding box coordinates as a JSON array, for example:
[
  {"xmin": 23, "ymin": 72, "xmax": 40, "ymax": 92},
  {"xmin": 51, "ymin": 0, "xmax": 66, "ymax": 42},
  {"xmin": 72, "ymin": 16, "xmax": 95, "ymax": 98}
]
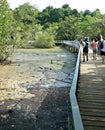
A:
[{"xmin": 0, "ymin": 0, "xmax": 11, "ymax": 61}]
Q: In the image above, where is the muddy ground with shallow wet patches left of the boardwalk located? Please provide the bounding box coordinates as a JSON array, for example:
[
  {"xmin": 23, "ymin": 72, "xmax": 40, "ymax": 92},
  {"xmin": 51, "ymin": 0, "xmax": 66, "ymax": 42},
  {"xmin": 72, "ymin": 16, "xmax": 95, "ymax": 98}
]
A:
[{"xmin": 0, "ymin": 47, "xmax": 76, "ymax": 130}]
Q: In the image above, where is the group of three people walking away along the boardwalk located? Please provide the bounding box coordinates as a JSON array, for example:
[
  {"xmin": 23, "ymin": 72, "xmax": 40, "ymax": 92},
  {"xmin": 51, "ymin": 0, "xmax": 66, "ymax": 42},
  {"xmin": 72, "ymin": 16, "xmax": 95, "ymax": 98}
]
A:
[{"xmin": 81, "ymin": 35, "xmax": 105, "ymax": 63}]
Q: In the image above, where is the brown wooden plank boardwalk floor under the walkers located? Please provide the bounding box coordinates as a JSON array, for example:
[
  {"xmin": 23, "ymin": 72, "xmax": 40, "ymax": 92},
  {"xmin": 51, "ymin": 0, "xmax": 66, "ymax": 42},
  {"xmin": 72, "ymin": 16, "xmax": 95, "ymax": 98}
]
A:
[{"xmin": 77, "ymin": 47, "xmax": 105, "ymax": 130}]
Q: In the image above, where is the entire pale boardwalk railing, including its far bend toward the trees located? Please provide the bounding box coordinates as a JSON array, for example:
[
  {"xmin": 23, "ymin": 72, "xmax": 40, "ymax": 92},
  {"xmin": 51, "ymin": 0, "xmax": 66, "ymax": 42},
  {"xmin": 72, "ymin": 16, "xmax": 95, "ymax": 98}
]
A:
[{"xmin": 56, "ymin": 40, "xmax": 84, "ymax": 130}]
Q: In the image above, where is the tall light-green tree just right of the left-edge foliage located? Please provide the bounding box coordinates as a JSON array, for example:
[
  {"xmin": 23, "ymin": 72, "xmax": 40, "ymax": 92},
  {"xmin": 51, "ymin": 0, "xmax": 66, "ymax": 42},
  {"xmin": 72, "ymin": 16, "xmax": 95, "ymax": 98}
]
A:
[{"xmin": 11, "ymin": 3, "xmax": 39, "ymax": 47}]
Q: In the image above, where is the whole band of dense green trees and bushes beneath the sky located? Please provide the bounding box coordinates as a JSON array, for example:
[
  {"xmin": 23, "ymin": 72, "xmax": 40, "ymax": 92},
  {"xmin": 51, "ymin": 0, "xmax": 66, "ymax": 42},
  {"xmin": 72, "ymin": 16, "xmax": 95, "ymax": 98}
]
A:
[{"xmin": 0, "ymin": 0, "xmax": 105, "ymax": 60}]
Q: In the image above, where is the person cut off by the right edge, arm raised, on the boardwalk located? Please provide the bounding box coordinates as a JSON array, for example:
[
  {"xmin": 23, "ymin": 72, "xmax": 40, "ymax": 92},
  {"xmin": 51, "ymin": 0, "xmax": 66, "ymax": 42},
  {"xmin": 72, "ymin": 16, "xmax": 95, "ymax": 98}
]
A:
[{"xmin": 100, "ymin": 35, "xmax": 105, "ymax": 63}]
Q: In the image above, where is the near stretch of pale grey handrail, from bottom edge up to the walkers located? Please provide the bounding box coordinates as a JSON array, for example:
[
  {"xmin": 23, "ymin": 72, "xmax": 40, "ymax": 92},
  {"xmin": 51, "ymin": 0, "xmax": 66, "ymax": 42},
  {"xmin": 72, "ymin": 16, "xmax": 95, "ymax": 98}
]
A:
[{"xmin": 70, "ymin": 49, "xmax": 84, "ymax": 130}]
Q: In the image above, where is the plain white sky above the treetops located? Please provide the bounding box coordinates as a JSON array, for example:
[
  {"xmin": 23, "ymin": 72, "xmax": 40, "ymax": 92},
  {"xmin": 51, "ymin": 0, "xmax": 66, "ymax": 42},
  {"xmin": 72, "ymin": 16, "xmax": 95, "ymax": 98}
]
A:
[{"xmin": 7, "ymin": 0, "xmax": 105, "ymax": 14}]
